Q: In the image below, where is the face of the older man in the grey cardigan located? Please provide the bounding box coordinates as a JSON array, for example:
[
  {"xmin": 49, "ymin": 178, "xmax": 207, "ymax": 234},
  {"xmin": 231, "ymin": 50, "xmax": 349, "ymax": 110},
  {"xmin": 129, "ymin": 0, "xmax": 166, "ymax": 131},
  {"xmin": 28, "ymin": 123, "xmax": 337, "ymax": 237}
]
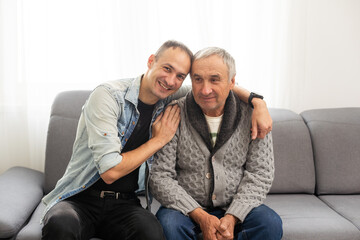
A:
[{"xmin": 191, "ymin": 55, "xmax": 235, "ymax": 117}]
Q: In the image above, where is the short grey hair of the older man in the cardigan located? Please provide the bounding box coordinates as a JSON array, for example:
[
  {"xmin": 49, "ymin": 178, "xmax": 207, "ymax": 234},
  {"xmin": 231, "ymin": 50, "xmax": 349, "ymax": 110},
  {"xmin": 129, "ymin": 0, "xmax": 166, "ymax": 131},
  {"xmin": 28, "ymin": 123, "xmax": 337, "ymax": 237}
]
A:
[{"xmin": 193, "ymin": 47, "xmax": 236, "ymax": 81}]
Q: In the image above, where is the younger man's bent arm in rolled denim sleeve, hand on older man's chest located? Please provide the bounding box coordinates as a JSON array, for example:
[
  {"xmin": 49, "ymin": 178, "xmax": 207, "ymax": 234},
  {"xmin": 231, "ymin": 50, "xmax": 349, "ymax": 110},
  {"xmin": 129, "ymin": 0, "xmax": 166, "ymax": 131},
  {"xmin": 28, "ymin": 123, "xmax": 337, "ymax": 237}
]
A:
[{"xmin": 83, "ymin": 86, "xmax": 180, "ymax": 184}]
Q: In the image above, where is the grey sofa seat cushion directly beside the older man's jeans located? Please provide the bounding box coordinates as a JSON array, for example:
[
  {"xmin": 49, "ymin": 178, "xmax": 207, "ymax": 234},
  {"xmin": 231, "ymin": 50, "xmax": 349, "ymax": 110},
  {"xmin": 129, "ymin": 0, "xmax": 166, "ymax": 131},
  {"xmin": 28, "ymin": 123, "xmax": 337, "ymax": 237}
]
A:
[{"xmin": 265, "ymin": 194, "xmax": 360, "ymax": 240}]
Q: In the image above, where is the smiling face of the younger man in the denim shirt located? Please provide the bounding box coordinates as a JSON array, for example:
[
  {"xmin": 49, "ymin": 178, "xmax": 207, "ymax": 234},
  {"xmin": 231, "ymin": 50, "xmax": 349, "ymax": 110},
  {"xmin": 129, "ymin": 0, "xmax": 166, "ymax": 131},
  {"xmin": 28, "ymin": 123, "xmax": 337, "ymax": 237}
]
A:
[{"xmin": 140, "ymin": 47, "xmax": 191, "ymax": 104}]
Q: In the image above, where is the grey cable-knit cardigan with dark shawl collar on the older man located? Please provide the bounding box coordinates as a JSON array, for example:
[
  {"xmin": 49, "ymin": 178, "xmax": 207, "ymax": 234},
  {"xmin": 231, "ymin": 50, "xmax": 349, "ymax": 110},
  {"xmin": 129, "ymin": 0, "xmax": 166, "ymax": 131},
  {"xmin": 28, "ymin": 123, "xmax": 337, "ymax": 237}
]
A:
[{"xmin": 149, "ymin": 91, "xmax": 274, "ymax": 221}]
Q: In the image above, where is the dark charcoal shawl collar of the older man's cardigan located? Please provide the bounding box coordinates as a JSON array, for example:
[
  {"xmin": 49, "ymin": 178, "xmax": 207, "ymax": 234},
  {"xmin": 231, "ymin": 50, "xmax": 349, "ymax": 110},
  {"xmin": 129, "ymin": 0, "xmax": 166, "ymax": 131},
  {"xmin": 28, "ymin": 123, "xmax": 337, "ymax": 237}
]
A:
[{"xmin": 186, "ymin": 91, "xmax": 241, "ymax": 155}]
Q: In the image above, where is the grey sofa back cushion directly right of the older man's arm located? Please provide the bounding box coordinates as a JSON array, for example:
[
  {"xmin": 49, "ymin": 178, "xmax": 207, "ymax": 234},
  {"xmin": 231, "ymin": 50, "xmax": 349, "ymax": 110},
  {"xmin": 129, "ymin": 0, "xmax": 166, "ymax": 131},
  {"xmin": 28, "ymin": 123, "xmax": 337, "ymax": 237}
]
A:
[{"xmin": 269, "ymin": 109, "xmax": 315, "ymax": 194}]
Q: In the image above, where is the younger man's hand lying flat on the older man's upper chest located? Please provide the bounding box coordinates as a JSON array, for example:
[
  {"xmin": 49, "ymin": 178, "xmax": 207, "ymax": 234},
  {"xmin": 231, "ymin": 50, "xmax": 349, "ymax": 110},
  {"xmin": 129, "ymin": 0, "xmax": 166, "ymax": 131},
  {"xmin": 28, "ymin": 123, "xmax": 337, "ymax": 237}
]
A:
[{"xmin": 152, "ymin": 104, "xmax": 180, "ymax": 145}]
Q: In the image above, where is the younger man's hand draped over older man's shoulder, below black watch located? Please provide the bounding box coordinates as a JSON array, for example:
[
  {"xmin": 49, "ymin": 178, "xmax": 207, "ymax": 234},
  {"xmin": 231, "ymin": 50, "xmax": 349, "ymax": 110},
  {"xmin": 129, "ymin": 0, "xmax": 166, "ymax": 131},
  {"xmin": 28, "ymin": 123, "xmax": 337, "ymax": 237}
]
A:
[{"xmin": 251, "ymin": 99, "xmax": 272, "ymax": 140}]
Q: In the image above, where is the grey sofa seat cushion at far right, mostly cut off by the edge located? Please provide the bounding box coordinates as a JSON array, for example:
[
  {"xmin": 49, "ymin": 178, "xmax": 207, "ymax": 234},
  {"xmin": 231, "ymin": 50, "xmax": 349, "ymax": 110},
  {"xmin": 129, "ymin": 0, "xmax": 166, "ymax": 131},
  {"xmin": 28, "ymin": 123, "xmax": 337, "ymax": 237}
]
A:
[{"xmin": 319, "ymin": 195, "xmax": 360, "ymax": 230}]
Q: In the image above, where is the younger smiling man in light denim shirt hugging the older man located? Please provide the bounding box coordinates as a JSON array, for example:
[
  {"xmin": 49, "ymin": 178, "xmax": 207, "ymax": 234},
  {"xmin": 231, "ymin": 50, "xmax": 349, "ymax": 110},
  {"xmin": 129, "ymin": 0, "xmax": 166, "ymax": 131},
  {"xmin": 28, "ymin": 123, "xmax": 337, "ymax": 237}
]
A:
[{"xmin": 42, "ymin": 41, "xmax": 271, "ymax": 240}]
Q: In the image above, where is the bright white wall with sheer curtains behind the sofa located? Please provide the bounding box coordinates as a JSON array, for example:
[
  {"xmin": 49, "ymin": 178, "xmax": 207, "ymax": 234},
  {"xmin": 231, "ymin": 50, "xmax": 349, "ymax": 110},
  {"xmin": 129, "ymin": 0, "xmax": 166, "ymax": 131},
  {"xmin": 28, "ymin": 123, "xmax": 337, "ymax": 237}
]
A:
[{"xmin": 0, "ymin": 0, "xmax": 360, "ymax": 173}]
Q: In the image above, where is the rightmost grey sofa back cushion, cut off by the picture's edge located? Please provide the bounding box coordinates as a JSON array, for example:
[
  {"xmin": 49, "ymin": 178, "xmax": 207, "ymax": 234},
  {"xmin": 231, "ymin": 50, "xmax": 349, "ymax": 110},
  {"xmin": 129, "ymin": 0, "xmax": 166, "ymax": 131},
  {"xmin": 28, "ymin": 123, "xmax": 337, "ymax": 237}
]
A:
[{"xmin": 301, "ymin": 108, "xmax": 360, "ymax": 194}]
